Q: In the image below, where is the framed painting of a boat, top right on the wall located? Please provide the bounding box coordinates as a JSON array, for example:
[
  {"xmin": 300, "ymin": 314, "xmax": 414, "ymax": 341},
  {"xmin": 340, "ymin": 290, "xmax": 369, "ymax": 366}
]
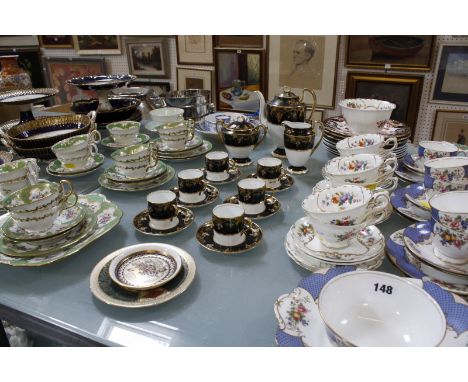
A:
[{"xmin": 345, "ymin": 35, "xmax": 435, "ymax": 71}]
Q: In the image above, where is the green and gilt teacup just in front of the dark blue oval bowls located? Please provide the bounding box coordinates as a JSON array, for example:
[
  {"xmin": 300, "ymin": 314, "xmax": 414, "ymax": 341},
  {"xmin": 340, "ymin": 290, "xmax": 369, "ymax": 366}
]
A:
[{"xmin": 51, "ymin": 130, "xmax": 101, "ymax": 170}]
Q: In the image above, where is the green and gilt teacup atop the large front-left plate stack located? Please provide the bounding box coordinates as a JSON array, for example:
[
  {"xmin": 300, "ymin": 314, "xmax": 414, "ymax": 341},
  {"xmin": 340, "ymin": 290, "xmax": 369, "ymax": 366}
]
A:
[{"xmin": 2, "ymin": 180, "xmax": 78, "ymax": 231}]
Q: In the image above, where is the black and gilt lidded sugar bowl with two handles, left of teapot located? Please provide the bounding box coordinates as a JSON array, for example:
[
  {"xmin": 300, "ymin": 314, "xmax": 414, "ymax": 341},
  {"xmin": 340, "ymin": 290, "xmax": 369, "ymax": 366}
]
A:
[{"xmin": 216, "ymin": 116, "xmax": 268, "ymax": 166}]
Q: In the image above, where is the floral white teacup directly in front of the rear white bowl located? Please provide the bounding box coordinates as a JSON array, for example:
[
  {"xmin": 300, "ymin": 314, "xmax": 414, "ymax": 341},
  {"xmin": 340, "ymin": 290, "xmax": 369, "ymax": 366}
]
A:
[{"xmin": 336, "ymin": 134, "xmax": 398, "ymax": 157}]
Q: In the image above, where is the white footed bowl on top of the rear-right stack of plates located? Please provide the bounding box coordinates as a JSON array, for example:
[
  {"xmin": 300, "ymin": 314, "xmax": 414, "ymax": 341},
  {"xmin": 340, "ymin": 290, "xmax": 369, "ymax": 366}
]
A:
[{"xmin": 339, "ymin": 98, "xmax": 396, "ymax": 134}]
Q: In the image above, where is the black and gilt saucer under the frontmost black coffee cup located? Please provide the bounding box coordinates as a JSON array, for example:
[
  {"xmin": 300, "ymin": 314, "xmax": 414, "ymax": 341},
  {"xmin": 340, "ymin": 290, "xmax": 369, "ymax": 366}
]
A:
[{"xmin": 197, "ymin": 220, "xmax": 263, "ymax": 255}]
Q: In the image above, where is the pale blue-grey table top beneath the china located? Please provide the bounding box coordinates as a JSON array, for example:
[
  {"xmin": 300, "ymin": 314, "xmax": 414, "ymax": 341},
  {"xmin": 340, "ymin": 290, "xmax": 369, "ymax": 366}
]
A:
[{"xmin": 0, "ymin": 118, "xmax": 409, "ymax": 346}]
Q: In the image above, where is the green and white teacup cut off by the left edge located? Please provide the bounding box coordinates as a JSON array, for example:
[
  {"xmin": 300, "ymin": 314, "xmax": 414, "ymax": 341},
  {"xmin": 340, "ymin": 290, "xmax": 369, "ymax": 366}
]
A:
[{"xmin": 0, "ymin": 158, "xmax": 40, "ymax": 194}]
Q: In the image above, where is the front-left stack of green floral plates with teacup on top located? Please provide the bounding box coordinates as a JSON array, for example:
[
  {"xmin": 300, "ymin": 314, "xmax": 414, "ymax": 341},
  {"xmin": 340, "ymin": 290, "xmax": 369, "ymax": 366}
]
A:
[{"xmin": 0, "ymin": 181, "xmax": 122, "ymax": 266}]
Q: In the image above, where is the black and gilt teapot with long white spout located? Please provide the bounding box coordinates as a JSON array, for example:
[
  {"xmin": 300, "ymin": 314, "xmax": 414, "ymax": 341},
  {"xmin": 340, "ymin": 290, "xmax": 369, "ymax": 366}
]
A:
[{"xmin": 255, "ymin": 86, "xmax": 317, "ymax": 158}]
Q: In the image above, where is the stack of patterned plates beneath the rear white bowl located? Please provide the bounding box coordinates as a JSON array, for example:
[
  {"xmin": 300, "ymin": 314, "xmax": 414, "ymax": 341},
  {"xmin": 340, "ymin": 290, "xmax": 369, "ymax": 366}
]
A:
[{"xmin": 323, "ymin": 116, "xmax": 411, "ymax": 160}]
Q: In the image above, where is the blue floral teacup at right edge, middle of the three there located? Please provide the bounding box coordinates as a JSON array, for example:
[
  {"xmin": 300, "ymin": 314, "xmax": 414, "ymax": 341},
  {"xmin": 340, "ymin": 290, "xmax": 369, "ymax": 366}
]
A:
[{"xmin": 424, "ymin": 157, "xmax": 468, "ymax": 192}]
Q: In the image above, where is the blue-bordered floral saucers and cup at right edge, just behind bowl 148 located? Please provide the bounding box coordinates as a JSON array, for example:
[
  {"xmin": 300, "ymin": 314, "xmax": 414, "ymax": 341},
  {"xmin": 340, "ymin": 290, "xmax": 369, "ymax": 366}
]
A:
[{"xmin": 387, "ymin": 191, "xmax": 468, "ymax": 296}]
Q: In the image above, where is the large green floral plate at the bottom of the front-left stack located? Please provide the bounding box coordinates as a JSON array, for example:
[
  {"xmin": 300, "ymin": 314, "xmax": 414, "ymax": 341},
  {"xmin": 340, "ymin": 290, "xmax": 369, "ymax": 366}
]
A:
[{"xmin": 0, "ymin": 193, "xmax": 122, "ymax": 267}]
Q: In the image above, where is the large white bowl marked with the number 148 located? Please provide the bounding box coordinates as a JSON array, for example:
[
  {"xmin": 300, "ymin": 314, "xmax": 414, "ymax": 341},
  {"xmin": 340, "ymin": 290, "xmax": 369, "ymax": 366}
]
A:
[{"xmin": 318, "ymin": 271, "xmax": 446, "ymax": 346}]
